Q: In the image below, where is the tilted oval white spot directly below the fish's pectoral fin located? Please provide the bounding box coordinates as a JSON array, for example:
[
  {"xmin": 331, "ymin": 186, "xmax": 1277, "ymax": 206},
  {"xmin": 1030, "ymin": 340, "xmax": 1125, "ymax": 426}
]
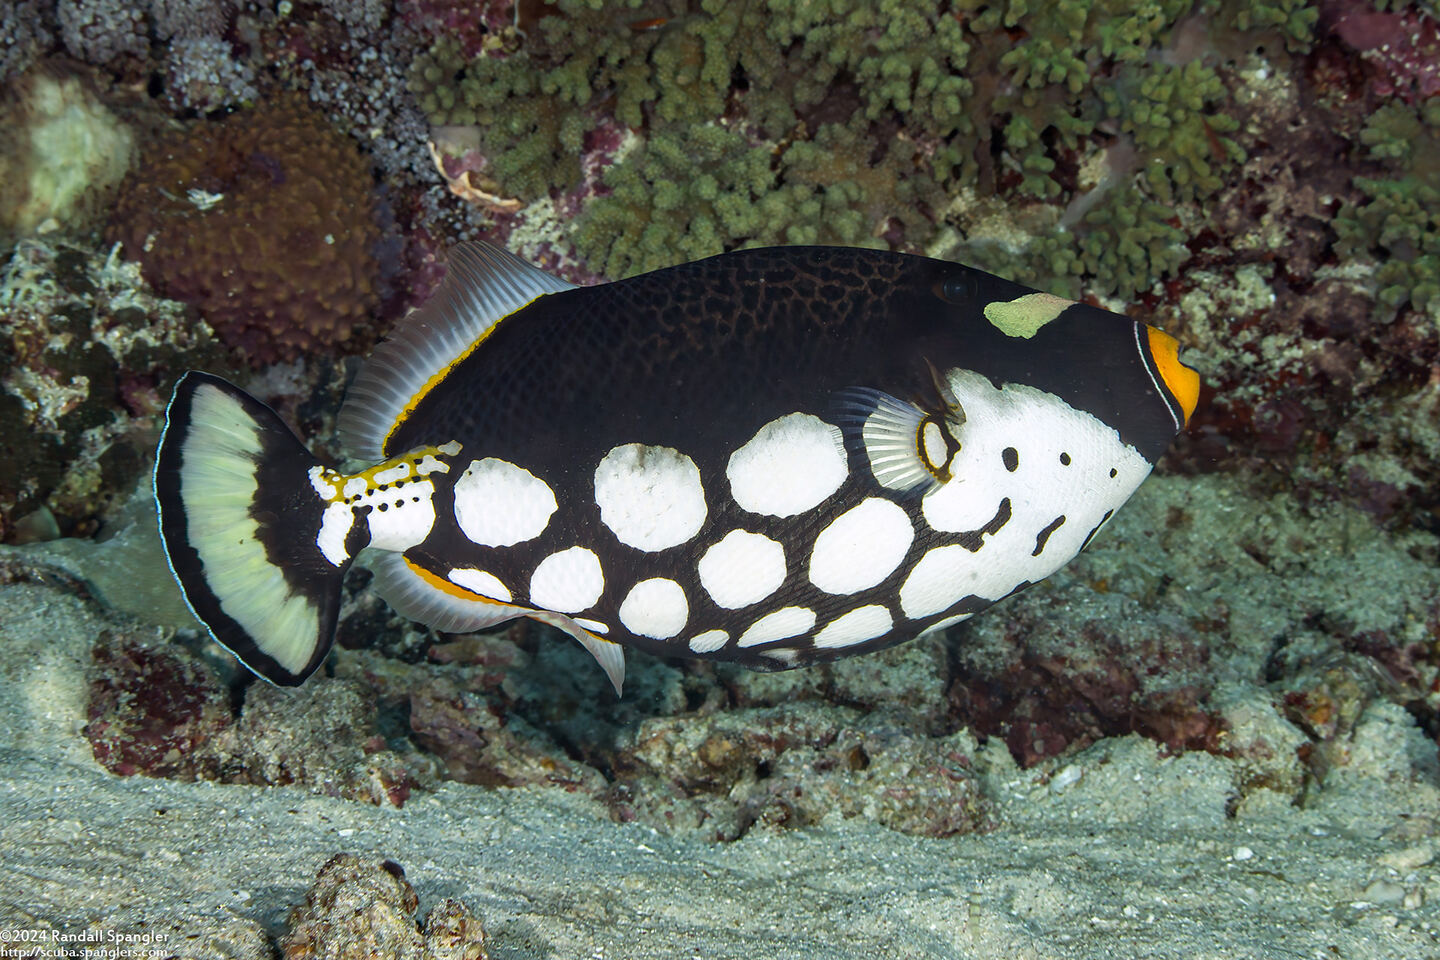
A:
[{"xmin": 809, "ymin": 497, "xmax": 914, "ymax": 594}]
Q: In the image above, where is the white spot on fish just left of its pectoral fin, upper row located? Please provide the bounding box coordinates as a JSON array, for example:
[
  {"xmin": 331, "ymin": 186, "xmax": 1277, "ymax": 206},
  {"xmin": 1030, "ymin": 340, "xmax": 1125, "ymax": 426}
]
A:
[{"xmin": 726, "ymin": 413, "xmax": 847, "ymax": 517}]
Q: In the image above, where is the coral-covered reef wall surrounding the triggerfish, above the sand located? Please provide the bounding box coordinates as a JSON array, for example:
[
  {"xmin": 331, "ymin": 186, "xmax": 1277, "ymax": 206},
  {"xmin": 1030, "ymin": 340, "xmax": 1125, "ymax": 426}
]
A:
[{"xmin": 8, "ymin": 0, "xmax": 1440, "ymax": 880}]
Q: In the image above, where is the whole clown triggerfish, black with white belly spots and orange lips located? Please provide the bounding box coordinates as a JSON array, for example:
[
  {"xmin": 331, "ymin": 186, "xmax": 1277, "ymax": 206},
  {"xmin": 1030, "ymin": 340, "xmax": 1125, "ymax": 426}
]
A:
[{"xmin": 154, "ymin": 243, "xmax": 1200, "ymax": 691}]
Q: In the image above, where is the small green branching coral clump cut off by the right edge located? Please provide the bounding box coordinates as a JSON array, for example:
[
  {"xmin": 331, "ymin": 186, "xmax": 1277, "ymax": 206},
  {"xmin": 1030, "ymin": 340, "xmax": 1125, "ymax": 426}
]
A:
[{"xmin": 1335, "ymin": 98, "xmax": 1440, "ymax": 322}]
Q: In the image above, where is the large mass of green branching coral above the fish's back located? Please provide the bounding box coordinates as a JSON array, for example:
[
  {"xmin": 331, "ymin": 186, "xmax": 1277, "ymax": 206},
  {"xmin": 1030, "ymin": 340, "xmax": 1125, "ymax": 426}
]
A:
[{"xmin": 410, "ymin": 0, "xmax": 1272, "ymax": 306}]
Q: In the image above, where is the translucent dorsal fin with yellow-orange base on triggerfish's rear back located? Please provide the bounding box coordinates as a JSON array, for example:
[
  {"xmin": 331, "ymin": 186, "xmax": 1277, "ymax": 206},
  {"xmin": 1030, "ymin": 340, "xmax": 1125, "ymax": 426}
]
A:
[{"xmin": 340, "ymin": 240, "xmax": 575, "ymax": 461}]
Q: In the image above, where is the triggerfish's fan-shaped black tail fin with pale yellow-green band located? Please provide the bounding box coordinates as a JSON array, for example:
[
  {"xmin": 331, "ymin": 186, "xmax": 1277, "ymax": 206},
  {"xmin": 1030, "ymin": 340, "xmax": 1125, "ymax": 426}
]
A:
[{"xmin": 154, "ymin": 371, "xmax": 354, "ymax": 687}]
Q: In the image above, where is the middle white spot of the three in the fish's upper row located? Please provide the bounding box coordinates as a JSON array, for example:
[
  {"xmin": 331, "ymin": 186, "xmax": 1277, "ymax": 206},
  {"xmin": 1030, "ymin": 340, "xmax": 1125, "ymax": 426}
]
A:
[{"xmin": 595, "ymin": 443, "xmax": 707, "ymax": 553}]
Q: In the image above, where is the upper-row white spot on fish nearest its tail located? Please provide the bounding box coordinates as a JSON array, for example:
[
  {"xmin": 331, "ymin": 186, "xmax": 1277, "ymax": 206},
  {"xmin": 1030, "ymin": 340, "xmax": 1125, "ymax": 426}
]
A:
[{"xmin": 454, "ymin": 458, "xmax": 556, "ymax": 547}]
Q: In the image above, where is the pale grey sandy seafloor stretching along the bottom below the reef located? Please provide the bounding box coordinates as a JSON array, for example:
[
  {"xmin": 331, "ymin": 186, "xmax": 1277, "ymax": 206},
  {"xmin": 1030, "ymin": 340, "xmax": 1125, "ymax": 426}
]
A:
[{"xmin": 0, "ymin": 481, "xmax": 1440, "ymax": 960}]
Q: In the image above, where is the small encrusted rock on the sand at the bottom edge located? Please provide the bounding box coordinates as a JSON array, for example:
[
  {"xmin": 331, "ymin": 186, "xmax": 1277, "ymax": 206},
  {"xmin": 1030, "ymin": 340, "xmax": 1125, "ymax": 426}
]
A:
[{"xmin": 279, "ymin": 853, "xmax": 490, "ymax": 960}]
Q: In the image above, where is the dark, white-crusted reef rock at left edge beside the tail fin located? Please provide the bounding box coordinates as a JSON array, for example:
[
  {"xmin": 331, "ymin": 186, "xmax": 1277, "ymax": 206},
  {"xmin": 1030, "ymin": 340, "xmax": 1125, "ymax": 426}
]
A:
[{"xmin": 0, "ymin": 240, "xmax": 232, "ymax": 541}]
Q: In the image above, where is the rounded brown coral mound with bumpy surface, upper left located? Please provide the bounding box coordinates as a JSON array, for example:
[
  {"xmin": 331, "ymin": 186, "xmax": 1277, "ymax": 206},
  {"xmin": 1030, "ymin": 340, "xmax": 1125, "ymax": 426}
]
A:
[{"xmin": 108, "ymin": 98, "xmax": 379, "ymax": 364}]
